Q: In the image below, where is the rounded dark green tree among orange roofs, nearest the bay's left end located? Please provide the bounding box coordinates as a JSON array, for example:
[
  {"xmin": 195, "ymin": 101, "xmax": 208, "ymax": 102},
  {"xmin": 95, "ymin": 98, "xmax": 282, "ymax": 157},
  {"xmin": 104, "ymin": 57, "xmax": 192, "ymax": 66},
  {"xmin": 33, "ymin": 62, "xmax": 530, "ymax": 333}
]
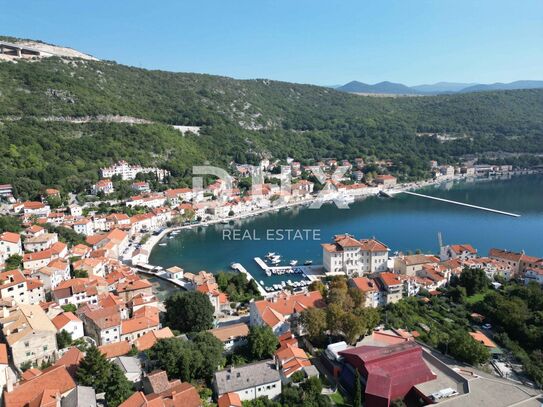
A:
[{"xmin": 166, "ymin": 291, "xmax": 214, "ymax": 332}]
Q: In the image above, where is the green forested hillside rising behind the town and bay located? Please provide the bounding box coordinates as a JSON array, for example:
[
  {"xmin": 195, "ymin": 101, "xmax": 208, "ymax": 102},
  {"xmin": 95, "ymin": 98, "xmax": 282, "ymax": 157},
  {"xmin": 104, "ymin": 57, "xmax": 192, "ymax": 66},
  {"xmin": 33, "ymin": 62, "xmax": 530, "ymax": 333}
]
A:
[{"xmin": 0, "ymin": 58, "xmax": 543, "ymax": 198}]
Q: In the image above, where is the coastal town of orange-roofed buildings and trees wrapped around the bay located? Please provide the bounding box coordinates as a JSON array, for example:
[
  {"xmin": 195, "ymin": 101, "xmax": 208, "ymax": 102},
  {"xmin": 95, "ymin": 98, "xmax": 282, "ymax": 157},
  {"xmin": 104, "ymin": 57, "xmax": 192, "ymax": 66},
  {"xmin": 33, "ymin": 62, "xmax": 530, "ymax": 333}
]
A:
[{"xmin": 0, "ymin": 158, "xmax": 543, "ymax": 407}]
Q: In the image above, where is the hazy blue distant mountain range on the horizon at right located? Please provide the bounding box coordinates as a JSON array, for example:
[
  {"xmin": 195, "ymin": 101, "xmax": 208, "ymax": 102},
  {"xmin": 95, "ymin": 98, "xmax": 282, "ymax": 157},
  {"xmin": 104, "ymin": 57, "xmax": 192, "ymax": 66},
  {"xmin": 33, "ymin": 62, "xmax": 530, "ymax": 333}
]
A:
[{"xmin": 335, "ymin": 80, "xmax": 543, "ymax": 95}]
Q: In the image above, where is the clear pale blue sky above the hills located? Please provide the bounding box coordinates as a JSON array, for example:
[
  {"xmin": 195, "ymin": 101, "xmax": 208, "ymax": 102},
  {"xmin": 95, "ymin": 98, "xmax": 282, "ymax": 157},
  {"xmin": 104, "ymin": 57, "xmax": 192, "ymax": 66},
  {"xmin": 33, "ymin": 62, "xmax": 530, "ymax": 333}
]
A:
[{"xmin": 0, "ymin": 0, "xmax": 543, "ymax": 85}]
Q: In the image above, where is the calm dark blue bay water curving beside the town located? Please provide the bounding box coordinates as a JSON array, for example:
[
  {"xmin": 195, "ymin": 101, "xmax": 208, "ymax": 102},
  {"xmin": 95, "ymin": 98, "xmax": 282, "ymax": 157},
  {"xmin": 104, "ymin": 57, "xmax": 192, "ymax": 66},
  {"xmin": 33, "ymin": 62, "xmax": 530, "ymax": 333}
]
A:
[{"xmin": 149, "ymin": 174, "xmax": 543, "ymax": 285}]
